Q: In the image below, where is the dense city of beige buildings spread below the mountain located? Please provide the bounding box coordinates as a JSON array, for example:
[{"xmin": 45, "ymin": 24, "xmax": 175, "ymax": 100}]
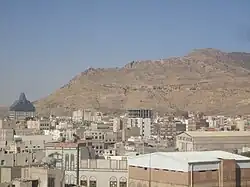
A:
[{"xmin": 0, "ymin": 93, "xmax": 250, "ymax": 187}]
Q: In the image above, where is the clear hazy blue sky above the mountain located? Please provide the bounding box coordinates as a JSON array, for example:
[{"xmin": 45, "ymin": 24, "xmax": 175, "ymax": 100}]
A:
[{"xmin": 0, "ymin": 0, "xmax": 250, "ymax": 105}]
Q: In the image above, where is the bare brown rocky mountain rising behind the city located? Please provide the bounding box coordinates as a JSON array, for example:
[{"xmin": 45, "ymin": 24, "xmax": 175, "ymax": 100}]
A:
[{"xmin": 34, "ymin": 48, "xmax": 250, "ymax": 114}]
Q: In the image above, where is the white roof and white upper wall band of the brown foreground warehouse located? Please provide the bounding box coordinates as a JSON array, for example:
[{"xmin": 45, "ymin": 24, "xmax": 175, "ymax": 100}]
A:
[{"xmin": 128, "ymin": 151, "xmax": 250, "ymax": 172}]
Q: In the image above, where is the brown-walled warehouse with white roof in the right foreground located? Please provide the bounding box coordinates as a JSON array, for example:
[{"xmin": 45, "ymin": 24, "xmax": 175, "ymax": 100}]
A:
[{"xmin": 128, "ymin": 151, "xmax": 250, "ymax": 187}]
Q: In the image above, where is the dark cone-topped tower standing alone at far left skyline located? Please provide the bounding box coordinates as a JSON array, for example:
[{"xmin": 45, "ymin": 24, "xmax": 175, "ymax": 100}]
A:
[{"xmin": 9, "ymin": 93, "xmax": 36, "ymax": 120}]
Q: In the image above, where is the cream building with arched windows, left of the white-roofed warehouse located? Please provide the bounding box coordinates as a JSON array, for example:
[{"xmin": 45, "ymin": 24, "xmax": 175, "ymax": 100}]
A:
[{"xmin": 46, "ymin": 142, "xmax": 127, "ymax": 187}]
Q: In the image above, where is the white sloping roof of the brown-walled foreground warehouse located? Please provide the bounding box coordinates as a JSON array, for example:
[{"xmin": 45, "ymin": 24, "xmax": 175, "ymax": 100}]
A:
[{"xmin": 128, "ymin": 151, "xmax": 250, "ymax": 172}]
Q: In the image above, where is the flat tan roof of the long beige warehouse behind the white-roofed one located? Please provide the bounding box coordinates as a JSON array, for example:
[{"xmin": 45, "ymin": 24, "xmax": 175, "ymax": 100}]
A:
[{"xmin": 180, "ymin": 131, "xmax": 250, "ymax": 137}]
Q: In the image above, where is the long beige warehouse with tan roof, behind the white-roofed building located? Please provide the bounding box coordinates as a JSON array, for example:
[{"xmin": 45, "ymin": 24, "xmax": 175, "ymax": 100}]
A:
[{"xmin": 176, "ymin": 131, "xmax": 250, "ymax": 152}]
